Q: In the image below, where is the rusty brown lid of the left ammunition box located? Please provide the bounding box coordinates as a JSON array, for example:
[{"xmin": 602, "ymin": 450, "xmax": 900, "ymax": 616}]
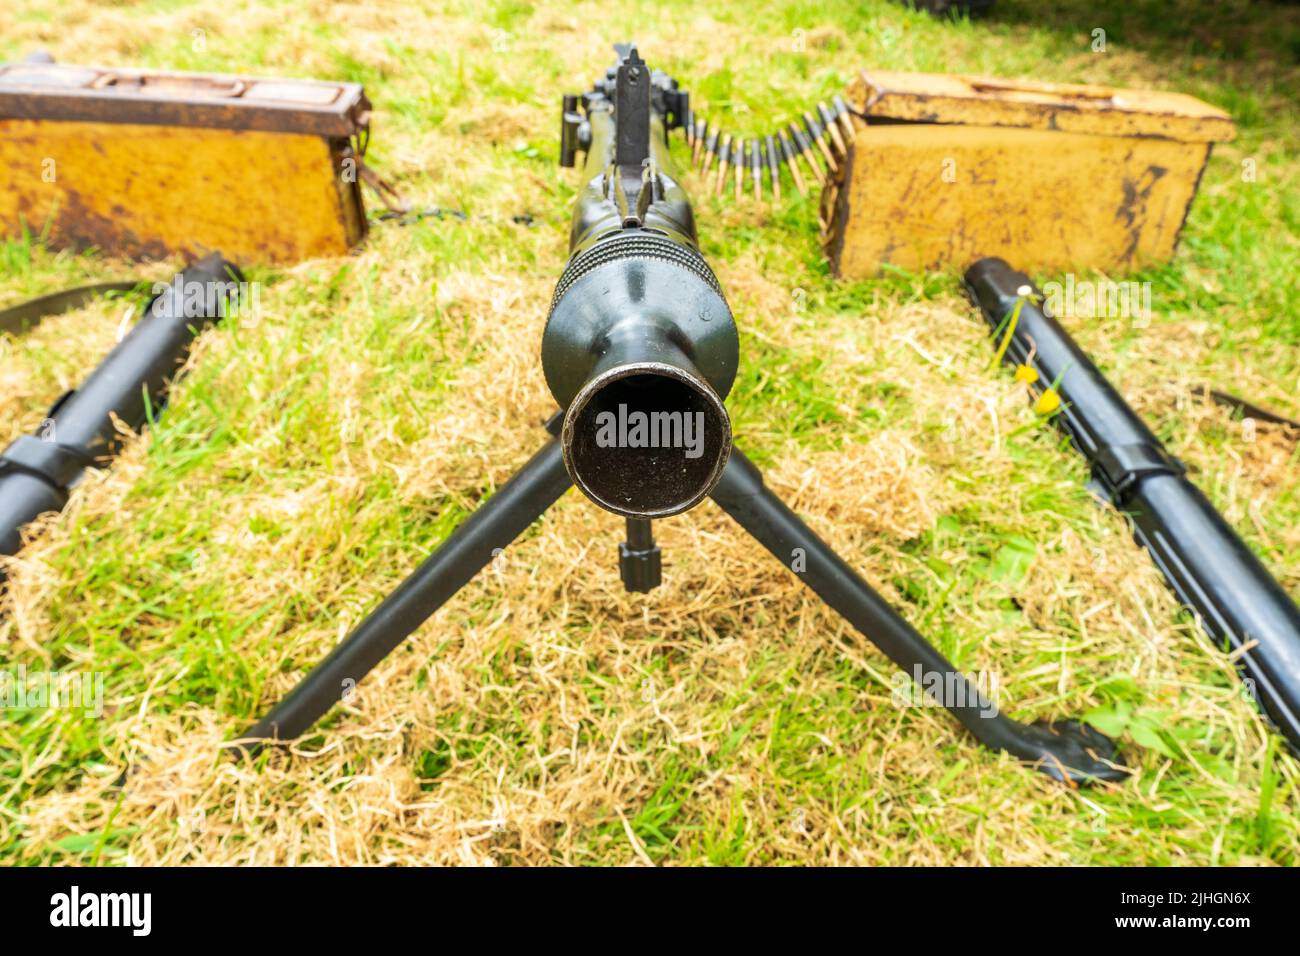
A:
[{"xmin": 0, "ymin": 62, "xmax": 371, "ymax": 137}]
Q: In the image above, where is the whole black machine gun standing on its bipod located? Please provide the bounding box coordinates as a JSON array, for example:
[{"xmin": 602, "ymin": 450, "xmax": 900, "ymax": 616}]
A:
[{"xmin": 241, "ymin": 46, "xmax": 1127, "ymax": 783}]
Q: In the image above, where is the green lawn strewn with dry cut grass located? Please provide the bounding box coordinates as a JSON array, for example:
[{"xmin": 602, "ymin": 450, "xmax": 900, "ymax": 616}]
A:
[{"xmin": 0, "ymin": 0, "xmax": 1300, "ymax": 865}]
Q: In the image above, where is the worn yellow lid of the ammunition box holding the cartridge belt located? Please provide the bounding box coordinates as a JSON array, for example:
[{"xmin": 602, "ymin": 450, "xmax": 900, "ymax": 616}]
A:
[{"xmin": 846, "ymin": 70, "xmax": 1234, "ymax": 143}]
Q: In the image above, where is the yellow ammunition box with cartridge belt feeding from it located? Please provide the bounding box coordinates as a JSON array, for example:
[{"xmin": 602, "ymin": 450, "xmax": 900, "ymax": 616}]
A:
[{"xmin": 822, "ymin": 72, "xmax": 1234, "ymax": 278}]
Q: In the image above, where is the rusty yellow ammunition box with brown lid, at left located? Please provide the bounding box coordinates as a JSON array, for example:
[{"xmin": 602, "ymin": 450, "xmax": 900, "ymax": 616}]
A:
[{"xmin": 0, "ymin": 62, "xmax": 371, "ymax": 263}]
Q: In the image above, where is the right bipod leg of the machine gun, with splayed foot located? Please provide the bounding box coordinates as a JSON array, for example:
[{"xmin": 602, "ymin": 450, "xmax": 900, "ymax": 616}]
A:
[{"xmin": 712, "ymin": 449, "xmax": 1126, "ymax": 780}]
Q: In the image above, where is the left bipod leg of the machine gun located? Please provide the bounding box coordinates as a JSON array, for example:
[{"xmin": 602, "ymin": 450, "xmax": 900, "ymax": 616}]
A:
[{"xmin": 241, "ymin": 440, "xmax": 569, "ymax": 749}]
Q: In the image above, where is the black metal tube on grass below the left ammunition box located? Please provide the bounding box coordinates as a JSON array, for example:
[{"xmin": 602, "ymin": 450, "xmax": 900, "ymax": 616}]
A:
[{"xmin": 0, "ymin": 252, "xmax": 243, "ymax": 554}]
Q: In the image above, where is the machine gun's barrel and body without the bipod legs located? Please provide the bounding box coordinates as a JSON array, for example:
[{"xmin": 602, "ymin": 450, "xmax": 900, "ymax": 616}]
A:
[{"xmin": 542, "ymin": 51, "xmax": 740, "ymax": 518}]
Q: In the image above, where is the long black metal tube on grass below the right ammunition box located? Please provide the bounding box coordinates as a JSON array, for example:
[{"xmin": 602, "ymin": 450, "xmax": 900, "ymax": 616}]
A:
[{"xmin": 966, "ymin": 259, "xmax": 1300, "ymax": 749}]
